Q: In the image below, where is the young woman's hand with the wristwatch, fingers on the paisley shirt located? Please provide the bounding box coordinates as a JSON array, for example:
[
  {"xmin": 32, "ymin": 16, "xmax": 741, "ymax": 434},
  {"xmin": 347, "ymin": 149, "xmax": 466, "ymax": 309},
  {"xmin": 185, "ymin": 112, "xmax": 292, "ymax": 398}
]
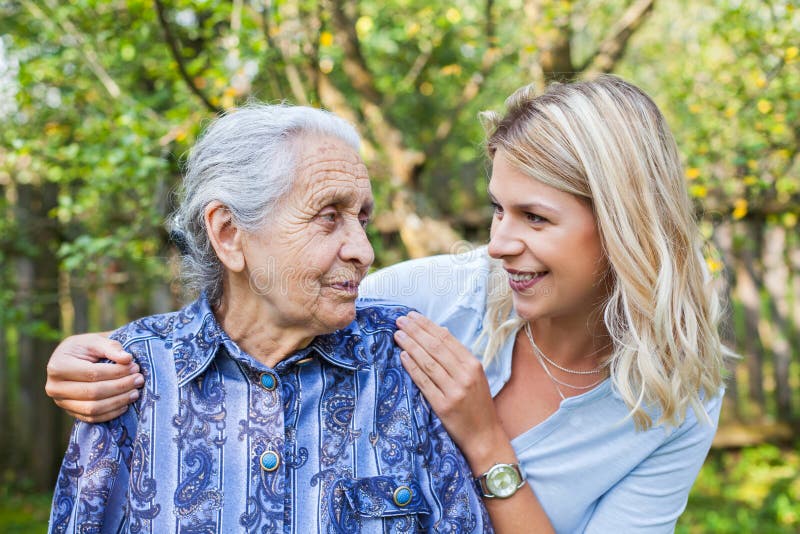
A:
[{"xmin": 395, "ymin": 312, "xmax": 508, "ymax": 469}]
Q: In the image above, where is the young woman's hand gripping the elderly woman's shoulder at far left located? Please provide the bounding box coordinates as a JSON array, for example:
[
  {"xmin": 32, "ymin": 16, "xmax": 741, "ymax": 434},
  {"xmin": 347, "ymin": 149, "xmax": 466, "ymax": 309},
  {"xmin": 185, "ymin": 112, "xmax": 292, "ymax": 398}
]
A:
[{"xmin": 45, "ymin": 334, "xmax": 144, "ymax": 423}]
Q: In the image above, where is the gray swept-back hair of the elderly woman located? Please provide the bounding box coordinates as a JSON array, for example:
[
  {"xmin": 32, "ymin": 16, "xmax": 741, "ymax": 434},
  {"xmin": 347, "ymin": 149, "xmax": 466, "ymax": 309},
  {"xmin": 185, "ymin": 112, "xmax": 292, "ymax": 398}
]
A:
[{"xmin": 172, "ymin": 103, "xmax": 361, "ymax": 305}]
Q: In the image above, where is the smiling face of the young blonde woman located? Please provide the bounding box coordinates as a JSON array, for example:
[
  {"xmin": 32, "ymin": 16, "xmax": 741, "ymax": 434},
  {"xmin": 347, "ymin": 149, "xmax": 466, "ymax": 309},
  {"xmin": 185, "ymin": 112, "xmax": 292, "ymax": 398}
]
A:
[{"xmin": 489, "ymin": 150, "xmax": 608, "ymax": 321}]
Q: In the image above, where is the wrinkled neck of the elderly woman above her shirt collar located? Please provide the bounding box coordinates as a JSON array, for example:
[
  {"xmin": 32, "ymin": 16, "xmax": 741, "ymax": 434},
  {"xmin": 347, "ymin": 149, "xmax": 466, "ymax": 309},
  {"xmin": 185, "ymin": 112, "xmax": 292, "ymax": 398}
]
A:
[{"xmin": 214, "ymin": 280, "xmax": 316, "ymax": 367}]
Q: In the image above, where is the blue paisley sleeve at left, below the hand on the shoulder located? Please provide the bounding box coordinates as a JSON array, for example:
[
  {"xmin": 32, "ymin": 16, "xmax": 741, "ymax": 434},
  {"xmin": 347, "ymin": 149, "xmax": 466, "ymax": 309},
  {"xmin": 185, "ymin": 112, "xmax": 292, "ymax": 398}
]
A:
[{"xmin": 49, "ymin": 407, "xmax": 136, "ymax": 533}]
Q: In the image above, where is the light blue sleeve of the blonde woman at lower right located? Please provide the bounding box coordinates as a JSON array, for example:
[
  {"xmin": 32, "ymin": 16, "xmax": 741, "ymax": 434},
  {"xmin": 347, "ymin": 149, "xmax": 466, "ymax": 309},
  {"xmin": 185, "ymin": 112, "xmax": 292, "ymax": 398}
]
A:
[{"xmin": 584, "ymin": 392, "xmax": 723, "ymax": 534}]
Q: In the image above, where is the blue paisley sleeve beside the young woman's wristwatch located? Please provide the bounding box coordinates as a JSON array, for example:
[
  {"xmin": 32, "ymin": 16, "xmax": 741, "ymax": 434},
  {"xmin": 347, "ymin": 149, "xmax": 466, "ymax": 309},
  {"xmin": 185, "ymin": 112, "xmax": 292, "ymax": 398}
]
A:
[{"xmin": 414, "ymin": 393, "xmax": 494, "ymax": 534}]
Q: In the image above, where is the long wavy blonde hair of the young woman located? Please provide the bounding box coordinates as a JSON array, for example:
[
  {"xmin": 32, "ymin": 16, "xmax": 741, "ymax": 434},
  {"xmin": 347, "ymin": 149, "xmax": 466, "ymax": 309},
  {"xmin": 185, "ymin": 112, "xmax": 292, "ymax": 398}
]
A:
[{"xmin": 478, "ymin": 76, "xmax": 731, "ymax": 430}]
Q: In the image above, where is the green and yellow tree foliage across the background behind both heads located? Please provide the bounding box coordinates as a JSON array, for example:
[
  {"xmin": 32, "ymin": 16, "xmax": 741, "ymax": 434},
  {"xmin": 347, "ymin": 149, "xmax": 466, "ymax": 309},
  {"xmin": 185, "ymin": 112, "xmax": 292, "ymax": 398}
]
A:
[{"xmin": 0, "ymin": 0, "xmax": 800, "ymax": 280}]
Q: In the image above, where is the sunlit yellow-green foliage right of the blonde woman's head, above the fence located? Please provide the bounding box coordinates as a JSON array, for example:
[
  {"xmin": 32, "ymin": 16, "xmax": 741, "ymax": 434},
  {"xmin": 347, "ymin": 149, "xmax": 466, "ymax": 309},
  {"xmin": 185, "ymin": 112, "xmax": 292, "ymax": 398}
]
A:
[{"xmin": 620, "ymin": 0, "xmax": 800, "ymax": 227}]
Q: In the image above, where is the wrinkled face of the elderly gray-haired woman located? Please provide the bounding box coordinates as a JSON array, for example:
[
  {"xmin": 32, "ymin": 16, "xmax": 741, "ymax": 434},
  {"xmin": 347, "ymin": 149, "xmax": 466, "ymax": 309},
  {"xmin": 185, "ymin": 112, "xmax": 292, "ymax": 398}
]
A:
[{"xmin": 243, "ymin": 137, "xmax": 374, "ymax": 335}]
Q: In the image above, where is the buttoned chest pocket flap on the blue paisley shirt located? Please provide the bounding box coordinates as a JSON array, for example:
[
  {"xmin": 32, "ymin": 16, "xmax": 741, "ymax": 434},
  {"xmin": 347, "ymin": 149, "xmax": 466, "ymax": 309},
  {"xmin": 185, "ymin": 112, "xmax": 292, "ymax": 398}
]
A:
[{"xmin": 343, "ymin": 475, "xmax": 431, "ymax": 532}]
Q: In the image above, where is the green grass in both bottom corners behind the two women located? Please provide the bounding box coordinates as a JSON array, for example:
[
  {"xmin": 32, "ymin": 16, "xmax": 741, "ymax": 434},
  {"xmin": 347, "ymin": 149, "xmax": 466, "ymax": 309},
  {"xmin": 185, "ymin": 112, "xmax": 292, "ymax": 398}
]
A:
[{"xmin": 0, "ymin": 444, "xmax": 800, "ymax": 534}]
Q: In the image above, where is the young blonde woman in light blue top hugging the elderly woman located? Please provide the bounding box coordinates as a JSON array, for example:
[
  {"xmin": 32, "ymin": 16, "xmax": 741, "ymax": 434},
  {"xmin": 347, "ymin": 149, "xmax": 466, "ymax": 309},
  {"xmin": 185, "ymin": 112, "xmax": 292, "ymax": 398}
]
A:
[{"xmin": 48, "ymin": 76, "xmax": 726, "ymax": 533}]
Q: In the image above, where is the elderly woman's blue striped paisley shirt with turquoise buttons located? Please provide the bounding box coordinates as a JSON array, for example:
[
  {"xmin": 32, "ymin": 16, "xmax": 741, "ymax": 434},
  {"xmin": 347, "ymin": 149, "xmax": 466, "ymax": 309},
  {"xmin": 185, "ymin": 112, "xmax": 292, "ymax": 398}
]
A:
[{"xmin": 50, "ymin": 298, "xmax": 491, "ymax": 533}]
